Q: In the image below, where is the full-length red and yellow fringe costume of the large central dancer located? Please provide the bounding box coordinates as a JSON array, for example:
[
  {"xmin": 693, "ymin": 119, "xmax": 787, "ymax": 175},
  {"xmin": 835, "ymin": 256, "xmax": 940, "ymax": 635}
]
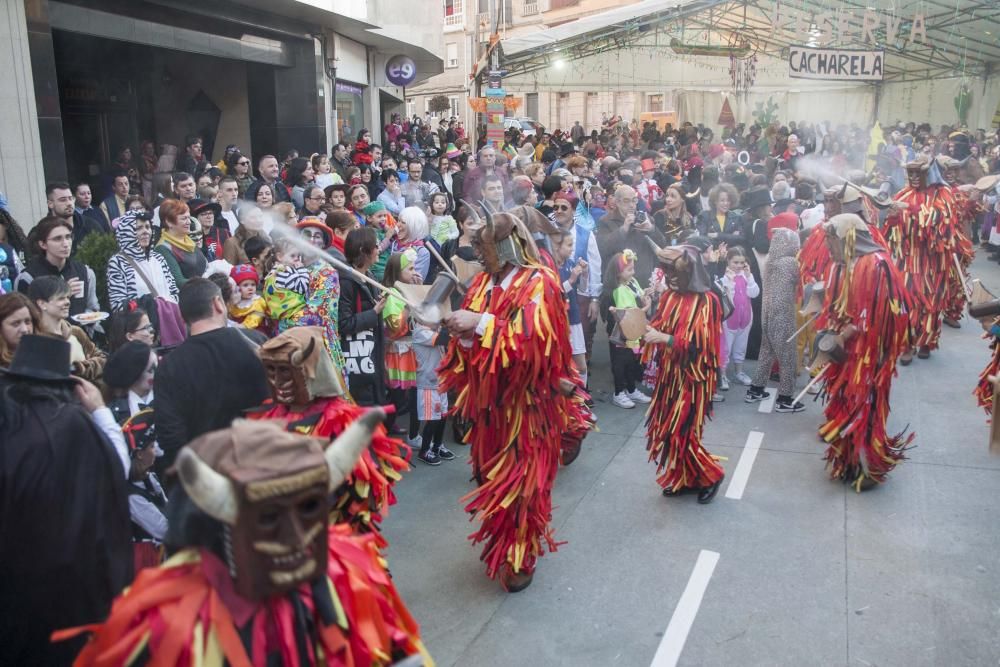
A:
[{"xmin": 438, "ymin": 264, "xmax": 590, "ymax": 579}]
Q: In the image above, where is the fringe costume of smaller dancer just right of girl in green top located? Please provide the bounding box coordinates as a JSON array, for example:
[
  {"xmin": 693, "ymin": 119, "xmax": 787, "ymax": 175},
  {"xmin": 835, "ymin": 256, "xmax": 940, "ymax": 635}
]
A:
[{"xmin": 642, "ymin": 289, "xmax": 724, "ymax": 493}]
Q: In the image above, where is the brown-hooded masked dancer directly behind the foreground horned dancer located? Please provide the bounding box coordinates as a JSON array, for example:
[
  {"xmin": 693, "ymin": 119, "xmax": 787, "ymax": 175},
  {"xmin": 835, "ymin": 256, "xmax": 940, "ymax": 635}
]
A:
[{"xmin": 247, "ymin": 327, "xmax": 410, "ymax": 549}]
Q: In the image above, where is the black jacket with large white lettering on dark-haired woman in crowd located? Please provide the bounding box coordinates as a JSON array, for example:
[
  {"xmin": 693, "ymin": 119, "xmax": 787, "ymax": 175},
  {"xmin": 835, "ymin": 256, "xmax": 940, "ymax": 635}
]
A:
[{"xmin": 338, "ymin": 272, "xmax": 386, "ymax": 405}]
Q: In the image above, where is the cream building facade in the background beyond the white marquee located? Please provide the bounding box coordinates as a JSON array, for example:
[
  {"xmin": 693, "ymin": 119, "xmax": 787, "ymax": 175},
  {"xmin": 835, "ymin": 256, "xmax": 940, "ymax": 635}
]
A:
[{"xmin": 406, "ymin": 0, "xmax": 674, "ymax": 142}]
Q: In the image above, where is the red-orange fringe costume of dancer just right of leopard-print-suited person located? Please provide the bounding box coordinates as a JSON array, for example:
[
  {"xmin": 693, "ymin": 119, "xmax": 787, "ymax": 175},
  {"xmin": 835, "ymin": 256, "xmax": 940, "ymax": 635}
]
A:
[{"xmin": 817, "ymin": 252, "xmax": 914, "ymax": 491}]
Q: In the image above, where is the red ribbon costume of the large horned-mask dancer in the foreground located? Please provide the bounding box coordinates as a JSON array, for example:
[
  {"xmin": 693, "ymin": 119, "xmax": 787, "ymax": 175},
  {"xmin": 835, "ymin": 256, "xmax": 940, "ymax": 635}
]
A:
[{"xmin": 53, "ymin": 526, "xmax": 433, "ymax": 667}]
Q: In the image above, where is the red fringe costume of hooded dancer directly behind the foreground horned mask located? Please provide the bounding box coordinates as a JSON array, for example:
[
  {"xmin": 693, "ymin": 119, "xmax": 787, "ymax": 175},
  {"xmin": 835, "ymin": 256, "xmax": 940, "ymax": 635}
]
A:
[{"xmin": 247, "ymin": 397, "xmax": 411, "ymax": 549}]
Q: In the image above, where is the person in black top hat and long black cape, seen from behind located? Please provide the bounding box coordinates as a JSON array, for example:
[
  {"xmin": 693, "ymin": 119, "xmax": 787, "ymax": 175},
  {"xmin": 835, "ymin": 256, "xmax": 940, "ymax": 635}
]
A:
[{"xmin": 0, "ymin": 334, "xmax": 132, "ymax": 665}]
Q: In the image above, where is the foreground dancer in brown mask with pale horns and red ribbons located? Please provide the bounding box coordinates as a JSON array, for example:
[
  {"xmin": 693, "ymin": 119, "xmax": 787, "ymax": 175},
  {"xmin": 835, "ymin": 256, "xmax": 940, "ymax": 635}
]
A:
[{"xmin": 54, "ymin": 409, "xmax": 432, "ymax": 667}]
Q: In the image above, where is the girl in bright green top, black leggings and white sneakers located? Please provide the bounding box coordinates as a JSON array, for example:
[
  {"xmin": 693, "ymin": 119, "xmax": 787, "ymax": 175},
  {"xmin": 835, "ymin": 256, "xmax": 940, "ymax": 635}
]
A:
[{"xmin": 600, "ymin": 249, "xmax": 650, "ymax": 409}]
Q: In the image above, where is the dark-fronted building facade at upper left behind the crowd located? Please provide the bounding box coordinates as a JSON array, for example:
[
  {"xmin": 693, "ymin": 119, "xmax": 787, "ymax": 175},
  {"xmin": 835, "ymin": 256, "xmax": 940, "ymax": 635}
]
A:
[{"xmin": 0, "ymin": 0, "xmax": 443, "ymax": 227}]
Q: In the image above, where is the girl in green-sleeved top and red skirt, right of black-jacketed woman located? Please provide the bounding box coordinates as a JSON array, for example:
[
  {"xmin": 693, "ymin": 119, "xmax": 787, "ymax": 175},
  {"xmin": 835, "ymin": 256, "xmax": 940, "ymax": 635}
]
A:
[{"xmin": 382, "ymin": 248, "xmax": 422, "ymax": 447}]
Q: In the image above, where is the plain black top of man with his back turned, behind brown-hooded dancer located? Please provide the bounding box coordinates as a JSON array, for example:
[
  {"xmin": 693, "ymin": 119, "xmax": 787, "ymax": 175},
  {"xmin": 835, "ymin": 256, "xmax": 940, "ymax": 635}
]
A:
[{"xmin": 154, "ymin": 327, "xmax": 271, "ymax": 472}]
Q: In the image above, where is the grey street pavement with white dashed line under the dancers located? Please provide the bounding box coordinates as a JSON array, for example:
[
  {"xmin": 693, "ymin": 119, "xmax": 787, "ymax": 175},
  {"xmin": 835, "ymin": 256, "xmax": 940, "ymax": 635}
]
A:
[{"xmin": 385, "ymin": 253, "xmax": 1000, "ymax": 667}]
